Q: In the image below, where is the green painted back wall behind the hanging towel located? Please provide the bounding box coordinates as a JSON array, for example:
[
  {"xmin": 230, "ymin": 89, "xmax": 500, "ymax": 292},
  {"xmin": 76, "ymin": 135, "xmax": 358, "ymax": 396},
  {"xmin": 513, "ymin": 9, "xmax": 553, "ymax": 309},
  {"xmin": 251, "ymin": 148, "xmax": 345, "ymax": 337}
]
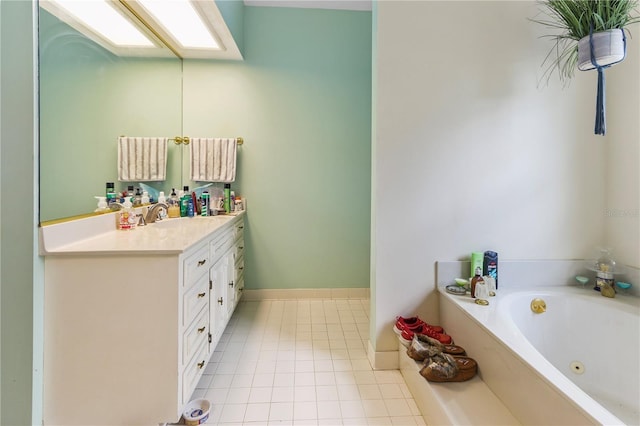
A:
[{"xmin": 183, "ymin": 7, "xmax": 371, "ymax": 289}]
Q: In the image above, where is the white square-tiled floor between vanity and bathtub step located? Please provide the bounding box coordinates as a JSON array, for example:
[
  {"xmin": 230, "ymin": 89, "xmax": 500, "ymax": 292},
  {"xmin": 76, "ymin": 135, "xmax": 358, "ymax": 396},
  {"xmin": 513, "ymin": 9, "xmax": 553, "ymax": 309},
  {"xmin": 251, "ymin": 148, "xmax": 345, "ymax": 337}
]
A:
[{"xmin": 193, "ymin": 299, "xmax": 425, "ymax": 426}]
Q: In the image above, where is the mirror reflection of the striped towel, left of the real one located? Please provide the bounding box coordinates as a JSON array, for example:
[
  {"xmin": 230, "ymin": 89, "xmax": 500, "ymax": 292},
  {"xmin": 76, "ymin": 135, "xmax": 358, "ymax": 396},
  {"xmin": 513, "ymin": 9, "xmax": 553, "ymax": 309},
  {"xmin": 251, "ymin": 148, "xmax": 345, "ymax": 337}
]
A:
[{"xmin": 118, "ymin": 136, "xmax": 167, "ymax": 182}]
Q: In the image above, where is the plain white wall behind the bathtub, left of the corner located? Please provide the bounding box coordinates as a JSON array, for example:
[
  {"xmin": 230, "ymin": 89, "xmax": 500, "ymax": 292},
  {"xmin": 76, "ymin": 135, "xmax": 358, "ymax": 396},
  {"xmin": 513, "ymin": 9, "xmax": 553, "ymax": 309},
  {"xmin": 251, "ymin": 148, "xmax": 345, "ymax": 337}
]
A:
[{"xmin": 371, "ymin": 1, "xmax": 608, "ymax": 360}]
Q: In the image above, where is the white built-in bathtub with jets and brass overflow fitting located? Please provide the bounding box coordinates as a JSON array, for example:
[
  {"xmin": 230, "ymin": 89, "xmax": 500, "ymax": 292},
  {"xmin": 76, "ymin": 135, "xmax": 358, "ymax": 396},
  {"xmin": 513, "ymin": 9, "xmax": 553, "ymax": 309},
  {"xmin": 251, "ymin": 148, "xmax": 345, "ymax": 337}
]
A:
[{"xmin": 440, "ymin": 286, "xmax": 640, "ymax": 425}]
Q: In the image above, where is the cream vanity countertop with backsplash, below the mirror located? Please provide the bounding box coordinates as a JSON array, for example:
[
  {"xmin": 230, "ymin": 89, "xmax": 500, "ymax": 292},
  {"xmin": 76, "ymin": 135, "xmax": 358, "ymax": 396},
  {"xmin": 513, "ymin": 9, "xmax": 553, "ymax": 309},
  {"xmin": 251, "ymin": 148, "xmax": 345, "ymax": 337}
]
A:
[{"xmin": 39, "ymin": 211, "xmax": 245, "ymax": 256}]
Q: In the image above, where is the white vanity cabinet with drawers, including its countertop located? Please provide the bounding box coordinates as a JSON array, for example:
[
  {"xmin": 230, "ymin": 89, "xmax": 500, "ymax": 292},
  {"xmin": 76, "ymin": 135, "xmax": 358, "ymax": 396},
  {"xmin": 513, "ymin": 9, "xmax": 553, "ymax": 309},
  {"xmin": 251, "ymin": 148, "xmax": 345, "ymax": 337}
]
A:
[{"xmin": 41, "ymin": 213, "xmax": 244, "ymax": 425}]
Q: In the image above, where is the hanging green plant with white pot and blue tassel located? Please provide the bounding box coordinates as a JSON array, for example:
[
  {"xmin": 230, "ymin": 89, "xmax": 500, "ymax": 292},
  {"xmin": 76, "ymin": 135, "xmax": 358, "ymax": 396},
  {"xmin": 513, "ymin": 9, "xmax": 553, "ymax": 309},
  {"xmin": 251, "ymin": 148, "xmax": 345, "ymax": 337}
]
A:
[{"xmin": 533, "ymin": 0, "xmax": 640, "ymax": 135}]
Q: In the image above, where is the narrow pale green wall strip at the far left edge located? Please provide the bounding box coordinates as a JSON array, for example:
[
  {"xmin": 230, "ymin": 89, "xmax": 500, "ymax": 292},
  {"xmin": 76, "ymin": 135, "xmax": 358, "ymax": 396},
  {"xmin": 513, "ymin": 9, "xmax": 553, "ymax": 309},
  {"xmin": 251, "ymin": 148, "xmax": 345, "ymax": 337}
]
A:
[{"xmin": 0, "ymin": 1, "xmax": 36, "ymax": 426}]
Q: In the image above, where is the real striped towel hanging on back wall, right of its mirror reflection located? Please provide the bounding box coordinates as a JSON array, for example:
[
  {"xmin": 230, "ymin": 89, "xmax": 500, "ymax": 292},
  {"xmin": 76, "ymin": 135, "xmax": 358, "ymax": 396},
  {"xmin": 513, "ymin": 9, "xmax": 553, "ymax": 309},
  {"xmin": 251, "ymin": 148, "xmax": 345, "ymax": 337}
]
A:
[{"xmin": 189, "ymin": 138, "xmax": 237, "ymax": 182}]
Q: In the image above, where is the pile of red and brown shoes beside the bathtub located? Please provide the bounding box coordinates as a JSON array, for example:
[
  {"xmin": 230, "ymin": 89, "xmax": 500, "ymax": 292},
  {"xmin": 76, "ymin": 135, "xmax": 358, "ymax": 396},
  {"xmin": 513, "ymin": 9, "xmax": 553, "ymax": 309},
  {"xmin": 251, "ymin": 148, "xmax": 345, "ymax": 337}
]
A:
[{"xmin": 393, "ymin": 317, "xmax": 478, "ymax": 382}]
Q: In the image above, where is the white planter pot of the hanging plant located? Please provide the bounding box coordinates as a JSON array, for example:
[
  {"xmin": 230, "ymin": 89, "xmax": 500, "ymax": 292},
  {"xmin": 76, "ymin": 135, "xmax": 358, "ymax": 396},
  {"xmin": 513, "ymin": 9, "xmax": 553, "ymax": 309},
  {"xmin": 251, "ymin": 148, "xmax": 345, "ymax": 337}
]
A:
[{"xmin": 578, "ymin": 29, "xmax": 625, "ymax": 71}]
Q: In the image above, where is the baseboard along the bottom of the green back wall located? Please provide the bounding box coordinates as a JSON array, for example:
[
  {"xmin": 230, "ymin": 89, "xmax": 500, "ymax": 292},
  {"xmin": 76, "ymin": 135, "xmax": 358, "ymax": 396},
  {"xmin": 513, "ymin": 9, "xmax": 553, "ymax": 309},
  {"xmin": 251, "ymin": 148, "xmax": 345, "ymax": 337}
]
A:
[{"xmin": 242, "ymin": 288, "xmax": 369, "ymax": 301}]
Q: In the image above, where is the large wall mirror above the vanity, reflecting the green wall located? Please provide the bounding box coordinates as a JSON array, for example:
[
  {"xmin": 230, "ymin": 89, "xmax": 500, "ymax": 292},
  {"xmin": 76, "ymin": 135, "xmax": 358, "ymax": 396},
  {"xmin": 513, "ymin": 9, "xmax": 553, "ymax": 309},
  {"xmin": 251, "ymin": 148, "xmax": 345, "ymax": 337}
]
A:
[{"xmin": 39, "ymin": 8, "xmax": 183, "ymax": 223}]
